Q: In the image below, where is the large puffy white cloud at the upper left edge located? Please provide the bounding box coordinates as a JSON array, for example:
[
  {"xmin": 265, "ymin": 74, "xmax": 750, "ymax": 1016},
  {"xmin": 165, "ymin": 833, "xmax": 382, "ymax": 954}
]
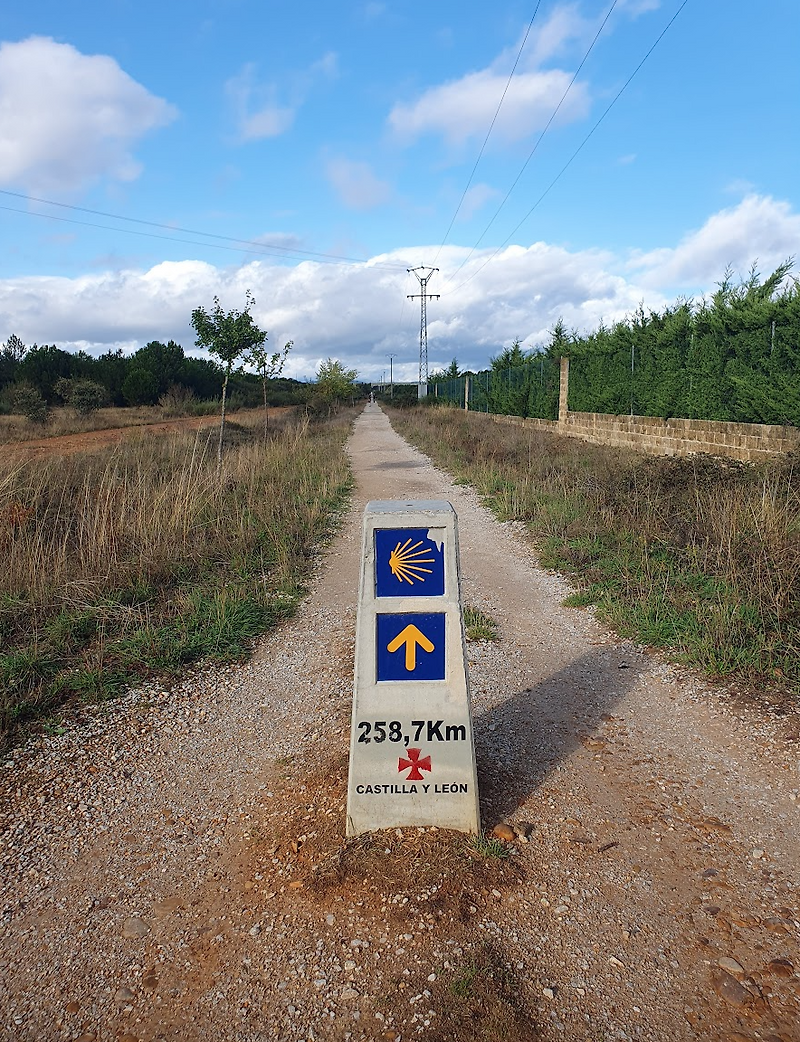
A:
[{"xmin": 0, "ymin": 36, "xmax": 177, "ymax": 193}]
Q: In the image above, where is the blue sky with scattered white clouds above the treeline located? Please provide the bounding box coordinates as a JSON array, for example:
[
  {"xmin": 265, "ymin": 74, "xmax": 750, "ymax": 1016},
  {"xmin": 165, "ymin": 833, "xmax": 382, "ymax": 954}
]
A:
[{"xmin": 0, "ymin": 0, "xmax": 800, "ymax": 381}]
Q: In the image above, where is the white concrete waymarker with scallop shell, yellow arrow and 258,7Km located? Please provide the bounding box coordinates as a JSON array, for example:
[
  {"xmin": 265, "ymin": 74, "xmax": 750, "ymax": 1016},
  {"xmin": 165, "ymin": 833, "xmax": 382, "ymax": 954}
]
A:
[{"xmin": 347, "ymin": 499, "xmax": 480, "ymax": 836}]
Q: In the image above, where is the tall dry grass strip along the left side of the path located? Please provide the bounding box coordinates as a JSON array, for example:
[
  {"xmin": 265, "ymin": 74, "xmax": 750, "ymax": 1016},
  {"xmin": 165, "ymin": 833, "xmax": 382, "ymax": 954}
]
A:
[{"xmin": 0, "ymin": 408, "xmax": 349, "ymax": 750}]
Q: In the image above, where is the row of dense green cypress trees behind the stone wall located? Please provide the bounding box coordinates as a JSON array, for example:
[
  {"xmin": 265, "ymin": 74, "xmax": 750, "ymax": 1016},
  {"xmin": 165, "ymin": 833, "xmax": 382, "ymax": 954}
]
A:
[{"xmin": 439, "ymin": 261, "xmax": 800, "ymax": 426}]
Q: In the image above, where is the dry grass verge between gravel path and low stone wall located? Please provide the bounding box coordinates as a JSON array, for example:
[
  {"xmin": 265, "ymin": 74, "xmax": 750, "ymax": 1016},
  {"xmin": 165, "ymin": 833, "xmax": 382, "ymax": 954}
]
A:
[{"xmin": 393, "ymin": 408, "xmax": 800, "ymax": 697}]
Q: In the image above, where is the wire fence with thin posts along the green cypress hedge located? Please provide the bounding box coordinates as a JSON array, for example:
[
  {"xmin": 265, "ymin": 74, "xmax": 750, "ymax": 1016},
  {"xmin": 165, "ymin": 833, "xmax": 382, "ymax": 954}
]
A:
[{"xmin": 428, "ymin": 320, "xmax": 800, "ymax": 427}]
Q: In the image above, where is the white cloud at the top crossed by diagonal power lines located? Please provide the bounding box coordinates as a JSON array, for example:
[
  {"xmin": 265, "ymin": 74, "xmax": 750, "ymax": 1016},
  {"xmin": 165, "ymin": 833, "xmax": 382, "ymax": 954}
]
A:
[{"xmin": 389, "ymin": 4, "xmax": 591, "ymax": 146}]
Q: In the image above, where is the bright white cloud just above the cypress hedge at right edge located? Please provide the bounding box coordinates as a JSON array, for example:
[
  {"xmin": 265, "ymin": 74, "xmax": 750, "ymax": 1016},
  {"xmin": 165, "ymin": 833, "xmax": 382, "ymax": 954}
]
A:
[{"xmin": 629, "ymin": 195, "xmax": 800, "ymax": 293}]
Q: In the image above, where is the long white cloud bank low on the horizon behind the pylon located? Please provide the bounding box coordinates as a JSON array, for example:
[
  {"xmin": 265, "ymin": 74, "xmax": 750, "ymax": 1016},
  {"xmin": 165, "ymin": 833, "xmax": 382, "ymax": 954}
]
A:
[{"xmin": 0, "ymin": 244, "xmax": 641, "ymax": 379}]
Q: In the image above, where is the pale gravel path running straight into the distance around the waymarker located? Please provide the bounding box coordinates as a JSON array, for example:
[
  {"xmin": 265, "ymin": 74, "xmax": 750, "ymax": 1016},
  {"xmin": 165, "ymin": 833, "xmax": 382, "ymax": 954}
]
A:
[{"xmin": 0, "ymin": 406, "xmax": 800, "ymax": 1042}]
